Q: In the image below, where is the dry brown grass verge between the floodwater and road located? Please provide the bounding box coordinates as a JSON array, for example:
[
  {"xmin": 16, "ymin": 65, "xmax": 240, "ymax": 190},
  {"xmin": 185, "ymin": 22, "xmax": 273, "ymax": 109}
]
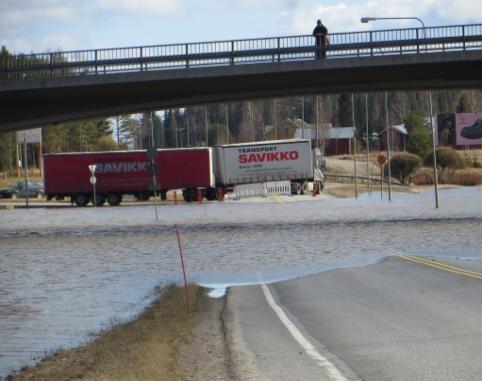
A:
[{"xmin": 7, "ymin": 285, "xmax": 206, "ymax": 381}]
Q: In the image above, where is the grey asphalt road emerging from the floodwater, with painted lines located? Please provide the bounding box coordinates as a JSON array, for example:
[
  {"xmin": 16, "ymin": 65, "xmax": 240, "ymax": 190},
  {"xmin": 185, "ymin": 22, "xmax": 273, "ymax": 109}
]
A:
[{"xmin": 224, "ymin": 253, "xmax": 482, "ymax": 381}]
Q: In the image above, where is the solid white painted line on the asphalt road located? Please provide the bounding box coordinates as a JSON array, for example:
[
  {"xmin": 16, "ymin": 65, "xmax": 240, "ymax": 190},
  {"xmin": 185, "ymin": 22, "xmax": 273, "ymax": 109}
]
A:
[{"xmin": 261, "ymin": 284, "xmax": 347, "ymax": 381}]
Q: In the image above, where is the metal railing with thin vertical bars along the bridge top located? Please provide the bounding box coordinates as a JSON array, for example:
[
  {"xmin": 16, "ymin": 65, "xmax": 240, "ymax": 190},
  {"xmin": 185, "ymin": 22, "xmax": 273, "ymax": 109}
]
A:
[{"xmin": 0, "ymin": 24, "xmax": 482, "ymax": 79}]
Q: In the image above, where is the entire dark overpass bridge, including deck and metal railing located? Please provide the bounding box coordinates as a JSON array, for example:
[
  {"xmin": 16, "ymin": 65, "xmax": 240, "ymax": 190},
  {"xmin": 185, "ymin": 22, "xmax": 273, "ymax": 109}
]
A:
[{"xmin": 0, "ymin": 24, "xmax": 482, "ymax": 131}]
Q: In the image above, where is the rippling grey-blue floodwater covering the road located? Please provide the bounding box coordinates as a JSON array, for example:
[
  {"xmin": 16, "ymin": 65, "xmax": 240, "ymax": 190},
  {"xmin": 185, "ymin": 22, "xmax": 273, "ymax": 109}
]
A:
[{"xmin": 0, "ymin": 187, "xmax": 482, "ymax": 377}]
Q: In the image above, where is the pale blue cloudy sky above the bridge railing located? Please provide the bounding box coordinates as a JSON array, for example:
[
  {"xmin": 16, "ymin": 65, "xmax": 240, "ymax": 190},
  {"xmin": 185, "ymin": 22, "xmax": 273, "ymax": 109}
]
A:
[{"xmin": 0, "ymin": 0, "xmax": 482, "ymax": 53}]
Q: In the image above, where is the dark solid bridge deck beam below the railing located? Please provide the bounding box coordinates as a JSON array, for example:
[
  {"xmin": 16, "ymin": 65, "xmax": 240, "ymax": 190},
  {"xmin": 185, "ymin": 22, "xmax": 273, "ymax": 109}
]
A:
[{"xmin": 0, "ymin": 51, "xmax": 482, "ymax": 131}]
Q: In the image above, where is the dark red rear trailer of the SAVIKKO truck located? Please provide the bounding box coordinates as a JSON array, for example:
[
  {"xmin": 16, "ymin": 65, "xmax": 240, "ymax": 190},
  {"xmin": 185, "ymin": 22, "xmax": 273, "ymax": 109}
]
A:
[{"xmin": 43, "ymin": 148, "xmax": 216, "ymax": 206}]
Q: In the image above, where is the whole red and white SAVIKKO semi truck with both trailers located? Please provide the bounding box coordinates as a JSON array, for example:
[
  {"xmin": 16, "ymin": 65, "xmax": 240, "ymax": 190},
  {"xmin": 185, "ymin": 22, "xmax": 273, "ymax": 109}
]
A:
[{"xmin": 43, "ymin": 139, "xmax": 323, "ymax": 206}]
